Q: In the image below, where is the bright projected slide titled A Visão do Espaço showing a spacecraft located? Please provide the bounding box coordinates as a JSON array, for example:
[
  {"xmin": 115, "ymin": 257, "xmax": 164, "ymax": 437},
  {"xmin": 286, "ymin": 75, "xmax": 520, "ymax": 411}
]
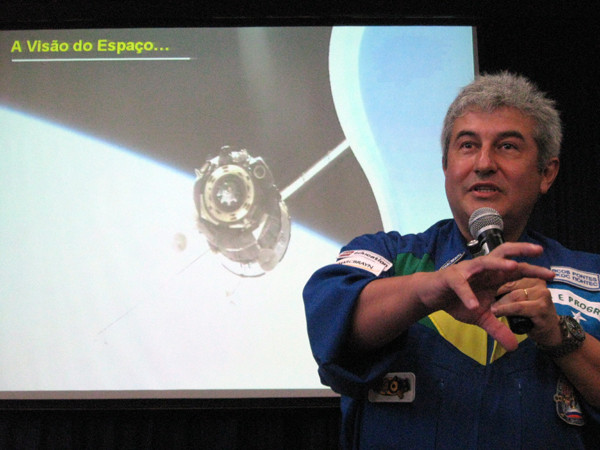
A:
[{"xmin": 0, "ymin": 27, "xmax": 474, "ymax": 398}]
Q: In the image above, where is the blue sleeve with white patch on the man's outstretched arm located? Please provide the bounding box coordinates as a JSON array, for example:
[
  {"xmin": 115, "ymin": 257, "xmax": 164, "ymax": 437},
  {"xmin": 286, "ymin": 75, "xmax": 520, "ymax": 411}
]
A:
[{"xmin": 303, "ymin": 233, "xmax": 410, "ymax": 397}]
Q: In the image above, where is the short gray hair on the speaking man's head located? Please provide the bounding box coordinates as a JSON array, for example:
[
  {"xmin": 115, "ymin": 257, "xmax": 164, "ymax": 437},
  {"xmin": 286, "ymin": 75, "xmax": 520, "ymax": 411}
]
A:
[{"xmin": 442, "ymin": 72, "xmax": 562, "ymax": 171}]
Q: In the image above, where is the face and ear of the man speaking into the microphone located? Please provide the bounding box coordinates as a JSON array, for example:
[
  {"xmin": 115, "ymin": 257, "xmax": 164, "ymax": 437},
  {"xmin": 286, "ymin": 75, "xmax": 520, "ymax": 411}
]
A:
[{"xmin": 444, "ymin": 107, "xmax": 558, "ymax": 240}]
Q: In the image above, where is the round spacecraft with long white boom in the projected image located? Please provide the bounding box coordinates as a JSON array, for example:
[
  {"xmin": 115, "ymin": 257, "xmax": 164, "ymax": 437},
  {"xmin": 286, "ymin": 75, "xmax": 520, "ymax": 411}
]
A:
[{"xmin": 194, "ymin": 141, "xmax": 349, "ymax": 277}]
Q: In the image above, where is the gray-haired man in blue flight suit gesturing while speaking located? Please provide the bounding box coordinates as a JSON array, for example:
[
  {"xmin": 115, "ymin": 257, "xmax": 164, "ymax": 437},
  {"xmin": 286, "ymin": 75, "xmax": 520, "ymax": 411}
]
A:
[{"xmin": 304, "ymin": 73, "xmax": 600, "ymax": 449}]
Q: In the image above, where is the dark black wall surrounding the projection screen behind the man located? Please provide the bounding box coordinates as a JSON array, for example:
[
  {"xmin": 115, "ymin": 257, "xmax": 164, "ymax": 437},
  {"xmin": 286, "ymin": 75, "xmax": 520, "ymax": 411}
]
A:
[{"xmin": 0, "ymin": 0, "xmax": 600, "ymax": 449}]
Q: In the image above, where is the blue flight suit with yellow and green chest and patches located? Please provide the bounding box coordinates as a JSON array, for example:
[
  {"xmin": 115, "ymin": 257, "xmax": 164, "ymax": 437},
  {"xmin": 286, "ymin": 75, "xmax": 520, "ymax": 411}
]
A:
[{"xmin": 303, "ymin": 220, "xmax": 600, "ymax": 450}]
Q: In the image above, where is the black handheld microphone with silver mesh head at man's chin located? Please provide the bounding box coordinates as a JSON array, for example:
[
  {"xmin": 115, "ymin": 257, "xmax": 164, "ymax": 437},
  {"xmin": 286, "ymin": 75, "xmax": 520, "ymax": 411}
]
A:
[{"xmin": 467, "ymin": 207, "xmax": 533, "ymax": 334}]
